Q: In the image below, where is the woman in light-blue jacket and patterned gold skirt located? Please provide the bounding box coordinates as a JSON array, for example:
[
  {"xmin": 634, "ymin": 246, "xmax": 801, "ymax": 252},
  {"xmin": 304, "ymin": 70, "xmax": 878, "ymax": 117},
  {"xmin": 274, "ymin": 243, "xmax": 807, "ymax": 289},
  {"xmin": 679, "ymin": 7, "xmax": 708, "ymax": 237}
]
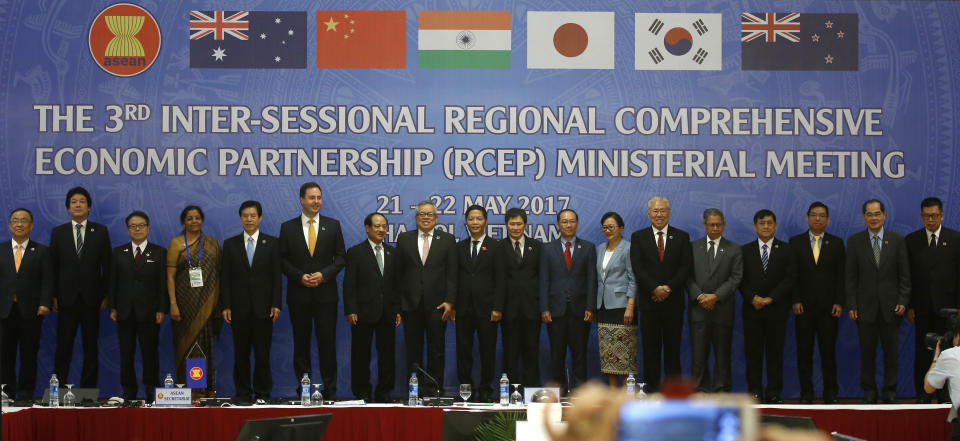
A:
[{"xmin": 596, "ymin": 211, "xmax": 638, "ymax": 387}]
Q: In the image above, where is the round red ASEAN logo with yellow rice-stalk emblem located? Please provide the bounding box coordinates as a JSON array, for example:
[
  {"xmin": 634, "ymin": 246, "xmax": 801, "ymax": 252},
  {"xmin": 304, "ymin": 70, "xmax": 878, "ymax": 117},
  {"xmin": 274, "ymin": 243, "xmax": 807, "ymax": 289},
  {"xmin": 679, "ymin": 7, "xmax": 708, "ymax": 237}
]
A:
[{"xmin": 88, "ymin": 3, "xmax": 160, "ymax": 77}]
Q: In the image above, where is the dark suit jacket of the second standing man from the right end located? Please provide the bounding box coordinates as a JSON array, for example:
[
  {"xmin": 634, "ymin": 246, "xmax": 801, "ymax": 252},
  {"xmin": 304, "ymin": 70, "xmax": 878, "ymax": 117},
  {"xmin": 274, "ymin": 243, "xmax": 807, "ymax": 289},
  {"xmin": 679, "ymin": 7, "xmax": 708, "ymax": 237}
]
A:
[{"xmin": 846, "ymin": 230, "xmax": 910, "ymax": 324}]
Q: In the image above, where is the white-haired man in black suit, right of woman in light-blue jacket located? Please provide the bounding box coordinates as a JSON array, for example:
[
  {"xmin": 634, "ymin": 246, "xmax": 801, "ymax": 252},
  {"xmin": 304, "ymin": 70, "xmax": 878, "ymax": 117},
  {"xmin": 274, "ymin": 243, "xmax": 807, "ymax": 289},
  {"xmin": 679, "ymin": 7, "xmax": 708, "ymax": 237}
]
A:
[{"xmin": 630, "ymin": 196, "xmax": 693, "ymax": 392}]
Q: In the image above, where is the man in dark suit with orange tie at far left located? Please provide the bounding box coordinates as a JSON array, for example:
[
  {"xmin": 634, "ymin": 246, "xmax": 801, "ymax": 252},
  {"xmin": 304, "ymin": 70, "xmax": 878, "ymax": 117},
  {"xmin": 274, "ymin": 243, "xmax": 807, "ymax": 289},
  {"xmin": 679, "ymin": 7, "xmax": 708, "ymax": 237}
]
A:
[{"xmin": 0, "ymin": 208, "xmax": 53, "ymax": 400}]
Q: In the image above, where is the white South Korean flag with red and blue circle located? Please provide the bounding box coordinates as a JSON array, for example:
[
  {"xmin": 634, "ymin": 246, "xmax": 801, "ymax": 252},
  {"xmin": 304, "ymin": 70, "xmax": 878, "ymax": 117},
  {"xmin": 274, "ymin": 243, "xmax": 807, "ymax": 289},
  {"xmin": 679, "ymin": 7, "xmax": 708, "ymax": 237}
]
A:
[{"xmin": 634, "ymin": 13, "xmax": 723, "ymax": 70}]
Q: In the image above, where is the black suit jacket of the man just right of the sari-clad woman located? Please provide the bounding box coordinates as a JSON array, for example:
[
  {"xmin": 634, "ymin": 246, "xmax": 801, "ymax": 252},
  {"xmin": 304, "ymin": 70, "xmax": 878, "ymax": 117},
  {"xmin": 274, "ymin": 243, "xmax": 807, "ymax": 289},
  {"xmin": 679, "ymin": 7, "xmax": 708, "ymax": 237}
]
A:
[{"xmin": 220, "ymin": 231, "xmax": 284, "ymax": 318}]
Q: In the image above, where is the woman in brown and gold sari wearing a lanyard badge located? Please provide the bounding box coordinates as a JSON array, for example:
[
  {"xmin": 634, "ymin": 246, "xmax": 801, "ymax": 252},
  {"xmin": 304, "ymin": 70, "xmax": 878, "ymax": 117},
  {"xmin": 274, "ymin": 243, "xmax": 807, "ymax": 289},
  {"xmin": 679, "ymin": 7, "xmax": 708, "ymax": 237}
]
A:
[{"xmin": 167, "ymin": 205, "xmax": 220, "ymax": 398}]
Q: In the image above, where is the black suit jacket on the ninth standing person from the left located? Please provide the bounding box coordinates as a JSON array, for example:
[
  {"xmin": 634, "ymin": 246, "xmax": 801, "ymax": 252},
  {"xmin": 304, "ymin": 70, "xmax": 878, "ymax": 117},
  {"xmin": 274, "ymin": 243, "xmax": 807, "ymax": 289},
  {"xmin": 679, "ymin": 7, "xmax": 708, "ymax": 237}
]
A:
[{"xmin": 457, "ymin": 236, "xmax": 503, "ymax": 320}]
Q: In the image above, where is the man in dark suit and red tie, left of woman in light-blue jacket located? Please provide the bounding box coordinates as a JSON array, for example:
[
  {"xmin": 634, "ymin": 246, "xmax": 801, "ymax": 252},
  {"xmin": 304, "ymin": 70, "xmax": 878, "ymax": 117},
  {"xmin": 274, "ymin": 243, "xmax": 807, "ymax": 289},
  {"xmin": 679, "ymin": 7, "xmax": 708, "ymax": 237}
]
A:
[{"xmin": 540, "ymin": 209, "xmax": 597, "ymax": 390}]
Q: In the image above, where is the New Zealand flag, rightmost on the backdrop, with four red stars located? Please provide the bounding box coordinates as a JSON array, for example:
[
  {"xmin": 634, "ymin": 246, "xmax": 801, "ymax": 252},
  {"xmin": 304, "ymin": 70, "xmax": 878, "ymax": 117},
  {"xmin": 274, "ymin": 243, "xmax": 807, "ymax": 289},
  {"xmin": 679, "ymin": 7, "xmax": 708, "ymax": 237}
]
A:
[{"xmin": 740, "ymin": 12, "xmax": 859, "ymax": 70}]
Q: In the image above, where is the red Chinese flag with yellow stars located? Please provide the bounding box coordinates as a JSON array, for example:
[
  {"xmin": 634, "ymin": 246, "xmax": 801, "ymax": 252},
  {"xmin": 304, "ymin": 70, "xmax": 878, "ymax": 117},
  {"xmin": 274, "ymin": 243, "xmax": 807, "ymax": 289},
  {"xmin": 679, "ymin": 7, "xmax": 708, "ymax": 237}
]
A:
[{"xmin": 317, "ymin": 11, "xmax": 407, "ymax": 69}]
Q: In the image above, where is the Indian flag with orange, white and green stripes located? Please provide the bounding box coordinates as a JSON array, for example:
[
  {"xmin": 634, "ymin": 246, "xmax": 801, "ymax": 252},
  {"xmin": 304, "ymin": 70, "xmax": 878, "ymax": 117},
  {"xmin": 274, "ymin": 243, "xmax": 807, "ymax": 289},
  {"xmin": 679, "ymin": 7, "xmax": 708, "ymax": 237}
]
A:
[{"xmin": 417, "ymin": 11, "xmax": 510, "ymax": 69}]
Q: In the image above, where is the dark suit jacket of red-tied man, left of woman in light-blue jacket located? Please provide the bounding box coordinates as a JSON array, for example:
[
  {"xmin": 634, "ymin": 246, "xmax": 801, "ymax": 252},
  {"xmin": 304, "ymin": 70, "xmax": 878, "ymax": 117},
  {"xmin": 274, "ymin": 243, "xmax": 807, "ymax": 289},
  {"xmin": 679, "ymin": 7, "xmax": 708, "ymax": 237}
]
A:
[{"xmin": 540, "ymin": 237, "xmax": 597, "ymax": 318}]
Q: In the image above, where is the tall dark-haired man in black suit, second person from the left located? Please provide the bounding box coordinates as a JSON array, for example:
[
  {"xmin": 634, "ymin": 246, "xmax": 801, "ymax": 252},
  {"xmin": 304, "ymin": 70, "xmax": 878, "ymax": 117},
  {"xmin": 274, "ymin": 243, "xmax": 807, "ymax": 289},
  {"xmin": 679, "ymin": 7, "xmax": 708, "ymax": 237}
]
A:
[{"xmin": 50, "ymin": 187, "xmax": 112, "ymax": 388}]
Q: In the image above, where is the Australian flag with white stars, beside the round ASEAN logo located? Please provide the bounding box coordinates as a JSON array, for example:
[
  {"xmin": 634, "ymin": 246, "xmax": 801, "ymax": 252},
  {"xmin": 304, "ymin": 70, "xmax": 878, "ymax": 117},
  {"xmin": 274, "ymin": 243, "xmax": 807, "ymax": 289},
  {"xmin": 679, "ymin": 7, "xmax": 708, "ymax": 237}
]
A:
[{"xmin": 190, "ymin": 11, "xmax": 308, "ymax": 69}]
